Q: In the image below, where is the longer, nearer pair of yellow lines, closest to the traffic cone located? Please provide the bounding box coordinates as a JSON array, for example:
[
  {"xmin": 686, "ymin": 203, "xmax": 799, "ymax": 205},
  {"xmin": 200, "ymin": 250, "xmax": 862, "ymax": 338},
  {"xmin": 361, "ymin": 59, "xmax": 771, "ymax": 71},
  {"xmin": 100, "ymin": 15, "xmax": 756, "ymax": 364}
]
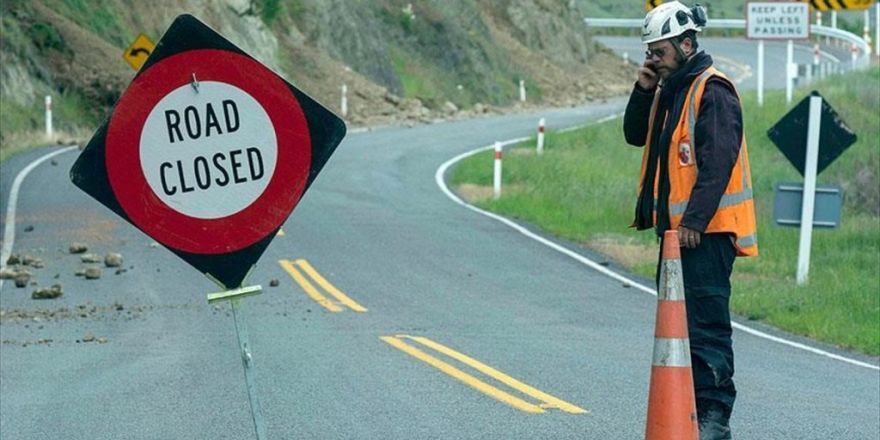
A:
[{"xmin": 379, "ymin": 335, "xmax": 589, "ymax": 414}]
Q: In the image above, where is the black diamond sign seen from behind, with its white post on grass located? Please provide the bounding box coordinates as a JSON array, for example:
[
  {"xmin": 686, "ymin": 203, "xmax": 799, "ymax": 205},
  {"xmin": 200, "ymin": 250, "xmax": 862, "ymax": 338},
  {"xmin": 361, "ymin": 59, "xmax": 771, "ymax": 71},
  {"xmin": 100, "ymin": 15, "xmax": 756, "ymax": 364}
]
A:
[{"xmin": 767, "ymin": 91, "xmax": 857, "ymax": 286}]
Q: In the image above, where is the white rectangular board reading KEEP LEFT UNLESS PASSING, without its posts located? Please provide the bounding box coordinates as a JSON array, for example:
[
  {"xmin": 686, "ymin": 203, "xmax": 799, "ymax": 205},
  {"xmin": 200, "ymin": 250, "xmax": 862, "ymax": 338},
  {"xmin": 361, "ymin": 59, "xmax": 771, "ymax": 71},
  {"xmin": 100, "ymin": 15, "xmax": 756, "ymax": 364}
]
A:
[{"xmin": 746, "ymin": 2, "xmax": 810, "ymax": 40}]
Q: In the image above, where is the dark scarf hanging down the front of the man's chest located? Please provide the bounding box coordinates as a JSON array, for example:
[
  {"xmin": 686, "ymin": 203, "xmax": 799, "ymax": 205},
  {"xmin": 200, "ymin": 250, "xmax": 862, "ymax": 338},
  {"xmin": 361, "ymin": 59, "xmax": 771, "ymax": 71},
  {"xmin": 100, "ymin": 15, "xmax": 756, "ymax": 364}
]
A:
[{"xmin": 636, "ymin": 51, "xmax": 712, "ymax": 235}]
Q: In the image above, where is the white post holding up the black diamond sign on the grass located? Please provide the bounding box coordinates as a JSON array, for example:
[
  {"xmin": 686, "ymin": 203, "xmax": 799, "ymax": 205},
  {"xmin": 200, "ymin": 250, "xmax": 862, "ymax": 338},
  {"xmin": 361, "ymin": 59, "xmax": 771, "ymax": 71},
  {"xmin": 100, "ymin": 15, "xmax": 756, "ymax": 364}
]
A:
[{"xmin": 797, "ymin": 94, "xmax": 822, "ymax": 286}]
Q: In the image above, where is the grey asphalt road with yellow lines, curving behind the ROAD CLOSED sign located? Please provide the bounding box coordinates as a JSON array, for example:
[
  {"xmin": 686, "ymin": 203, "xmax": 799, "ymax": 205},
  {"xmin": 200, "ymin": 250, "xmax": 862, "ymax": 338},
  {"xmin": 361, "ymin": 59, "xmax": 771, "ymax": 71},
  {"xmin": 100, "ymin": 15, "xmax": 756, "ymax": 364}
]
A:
[{"xmin": 0, "ymin": 83, "xmax": 880, "ymax": 440}]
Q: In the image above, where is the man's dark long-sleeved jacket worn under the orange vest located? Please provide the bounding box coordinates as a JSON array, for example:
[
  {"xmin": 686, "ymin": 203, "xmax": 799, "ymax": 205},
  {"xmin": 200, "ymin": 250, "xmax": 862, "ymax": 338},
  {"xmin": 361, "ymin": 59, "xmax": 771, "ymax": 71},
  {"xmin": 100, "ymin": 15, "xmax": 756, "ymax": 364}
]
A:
[{"xmin": 623, "ymin": 52, "xmax": 743, "ymax": 235}]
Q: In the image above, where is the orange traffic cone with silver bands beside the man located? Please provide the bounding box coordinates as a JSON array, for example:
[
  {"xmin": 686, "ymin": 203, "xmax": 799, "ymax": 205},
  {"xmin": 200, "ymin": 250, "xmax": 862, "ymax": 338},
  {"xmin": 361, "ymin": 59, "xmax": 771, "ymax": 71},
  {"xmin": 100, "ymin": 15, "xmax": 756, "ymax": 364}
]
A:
[{"xmin": 645, "ymin": 231, "xmax": 700, "ymax": 440}]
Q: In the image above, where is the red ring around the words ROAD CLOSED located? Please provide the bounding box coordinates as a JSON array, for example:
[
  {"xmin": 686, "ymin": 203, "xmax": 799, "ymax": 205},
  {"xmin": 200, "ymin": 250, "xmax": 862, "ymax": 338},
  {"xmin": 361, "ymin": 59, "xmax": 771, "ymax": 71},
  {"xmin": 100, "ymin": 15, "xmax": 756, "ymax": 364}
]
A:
[{"xmin": 105, "ymin": 49, "xmax": 312, "ymax": 254}]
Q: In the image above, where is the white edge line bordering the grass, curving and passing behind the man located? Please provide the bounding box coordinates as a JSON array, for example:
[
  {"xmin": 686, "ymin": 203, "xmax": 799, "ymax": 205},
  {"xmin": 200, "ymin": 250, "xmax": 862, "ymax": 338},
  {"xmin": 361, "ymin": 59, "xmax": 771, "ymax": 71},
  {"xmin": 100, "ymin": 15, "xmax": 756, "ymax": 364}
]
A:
[{"xmin": 434, "ymin": 113, "xmax": 880, "ymax": 371}]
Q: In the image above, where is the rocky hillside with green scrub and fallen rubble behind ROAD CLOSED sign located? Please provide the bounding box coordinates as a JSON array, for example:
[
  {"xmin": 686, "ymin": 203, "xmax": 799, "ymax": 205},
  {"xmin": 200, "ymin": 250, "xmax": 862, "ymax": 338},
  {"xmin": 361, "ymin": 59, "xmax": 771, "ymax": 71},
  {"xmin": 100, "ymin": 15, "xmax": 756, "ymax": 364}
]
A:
[{"xmin": 0, "ymin": 0, "xmax": 633, "ymax": 147}]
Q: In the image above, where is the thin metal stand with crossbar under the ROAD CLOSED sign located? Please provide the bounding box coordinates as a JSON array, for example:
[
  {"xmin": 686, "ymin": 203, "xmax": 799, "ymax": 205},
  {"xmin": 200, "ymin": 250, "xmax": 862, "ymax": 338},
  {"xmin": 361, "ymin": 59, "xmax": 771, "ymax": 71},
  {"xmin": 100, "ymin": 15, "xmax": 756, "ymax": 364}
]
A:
[{"xmin": 208, "ymin": 286, "xmax": 267, "ymax": 440}]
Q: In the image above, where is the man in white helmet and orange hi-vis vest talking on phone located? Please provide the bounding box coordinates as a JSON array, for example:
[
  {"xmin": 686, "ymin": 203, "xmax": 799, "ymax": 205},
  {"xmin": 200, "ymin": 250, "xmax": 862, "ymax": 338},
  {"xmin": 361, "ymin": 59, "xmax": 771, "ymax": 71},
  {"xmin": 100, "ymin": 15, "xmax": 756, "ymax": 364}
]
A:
[{"xmin": 623, "ymin": 1, "xmax": 758, "ymax": 440}]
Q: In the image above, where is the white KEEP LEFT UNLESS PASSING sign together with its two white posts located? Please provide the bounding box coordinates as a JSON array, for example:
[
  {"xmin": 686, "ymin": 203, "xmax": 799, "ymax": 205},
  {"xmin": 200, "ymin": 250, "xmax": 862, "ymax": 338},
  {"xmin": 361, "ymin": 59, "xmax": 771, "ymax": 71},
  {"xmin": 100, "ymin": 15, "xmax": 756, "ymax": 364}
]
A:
[{"xmin": 746, "ymin": 2, "xmax": 810, "ymax": 105}]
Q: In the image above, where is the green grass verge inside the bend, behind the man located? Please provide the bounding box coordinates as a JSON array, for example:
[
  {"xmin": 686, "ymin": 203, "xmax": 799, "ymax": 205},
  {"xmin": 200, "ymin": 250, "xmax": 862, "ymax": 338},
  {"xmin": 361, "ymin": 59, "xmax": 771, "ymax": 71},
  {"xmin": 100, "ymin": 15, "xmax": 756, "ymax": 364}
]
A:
[{"xmin": 451, "ymin": 67, "xmax": 880, "ymax": 355}]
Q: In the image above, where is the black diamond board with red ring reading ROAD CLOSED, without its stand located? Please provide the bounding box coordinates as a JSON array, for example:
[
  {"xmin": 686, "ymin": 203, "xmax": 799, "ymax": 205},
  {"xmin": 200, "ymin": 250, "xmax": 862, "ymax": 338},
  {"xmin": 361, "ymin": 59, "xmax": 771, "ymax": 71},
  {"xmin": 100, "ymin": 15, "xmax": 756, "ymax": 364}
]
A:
[{"xmin": 71, "ymin": 15, "xmax": 345, "ymax": 289}]
